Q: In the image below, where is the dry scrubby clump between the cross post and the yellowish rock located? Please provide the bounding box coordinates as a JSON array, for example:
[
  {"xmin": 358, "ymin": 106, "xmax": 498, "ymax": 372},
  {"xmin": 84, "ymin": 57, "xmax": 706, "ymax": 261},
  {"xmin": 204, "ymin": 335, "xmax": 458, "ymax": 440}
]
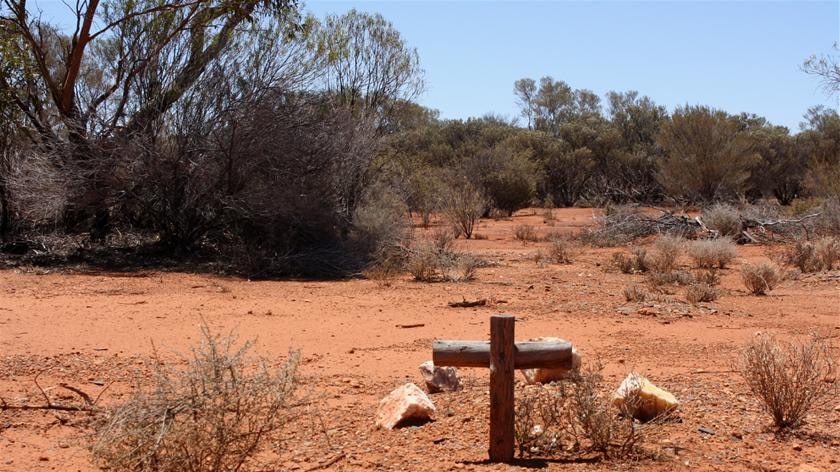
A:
[{"xmin": 515, "ymin": 366, "xmax": 661, "ymax": 459}]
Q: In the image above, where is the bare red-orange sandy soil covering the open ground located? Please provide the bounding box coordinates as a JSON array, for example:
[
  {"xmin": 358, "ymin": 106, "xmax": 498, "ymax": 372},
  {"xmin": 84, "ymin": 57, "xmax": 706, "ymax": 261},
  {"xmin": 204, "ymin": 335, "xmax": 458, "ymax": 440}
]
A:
[{"xmin": 0, "ymin": 209, "xmax": 840, "ymax": 471}]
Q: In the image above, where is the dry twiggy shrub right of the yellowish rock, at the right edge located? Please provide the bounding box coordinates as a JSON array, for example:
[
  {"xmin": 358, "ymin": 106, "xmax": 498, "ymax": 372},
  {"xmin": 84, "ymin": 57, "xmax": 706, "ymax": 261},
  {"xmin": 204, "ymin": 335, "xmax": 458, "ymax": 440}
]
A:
[{"xmin": 737, "ymin": 334, "xmax": 836, "ymax": 428}]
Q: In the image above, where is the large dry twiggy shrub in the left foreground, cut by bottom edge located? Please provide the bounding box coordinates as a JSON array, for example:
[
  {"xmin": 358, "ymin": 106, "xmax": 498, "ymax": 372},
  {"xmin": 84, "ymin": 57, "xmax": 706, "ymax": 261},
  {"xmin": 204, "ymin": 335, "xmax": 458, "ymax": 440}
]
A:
[{"xmin": 91, "ymin": 327, "xmax": 298, "ymax": 472}]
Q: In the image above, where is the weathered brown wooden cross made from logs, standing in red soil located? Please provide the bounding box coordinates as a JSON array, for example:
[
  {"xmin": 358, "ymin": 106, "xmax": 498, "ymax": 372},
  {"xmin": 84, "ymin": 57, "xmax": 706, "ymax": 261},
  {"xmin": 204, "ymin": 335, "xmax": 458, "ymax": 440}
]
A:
[{"xmin": 432, "ymin": 315, "xmax": 572, "ymax": 462}]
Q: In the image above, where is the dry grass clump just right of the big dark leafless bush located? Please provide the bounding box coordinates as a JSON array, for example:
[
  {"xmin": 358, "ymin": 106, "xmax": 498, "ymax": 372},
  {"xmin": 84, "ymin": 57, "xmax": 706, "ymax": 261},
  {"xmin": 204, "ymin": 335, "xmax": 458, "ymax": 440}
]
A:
[{"xmin": 405, "ymin": 233, "xmax": 482, "ymax": 282}]
